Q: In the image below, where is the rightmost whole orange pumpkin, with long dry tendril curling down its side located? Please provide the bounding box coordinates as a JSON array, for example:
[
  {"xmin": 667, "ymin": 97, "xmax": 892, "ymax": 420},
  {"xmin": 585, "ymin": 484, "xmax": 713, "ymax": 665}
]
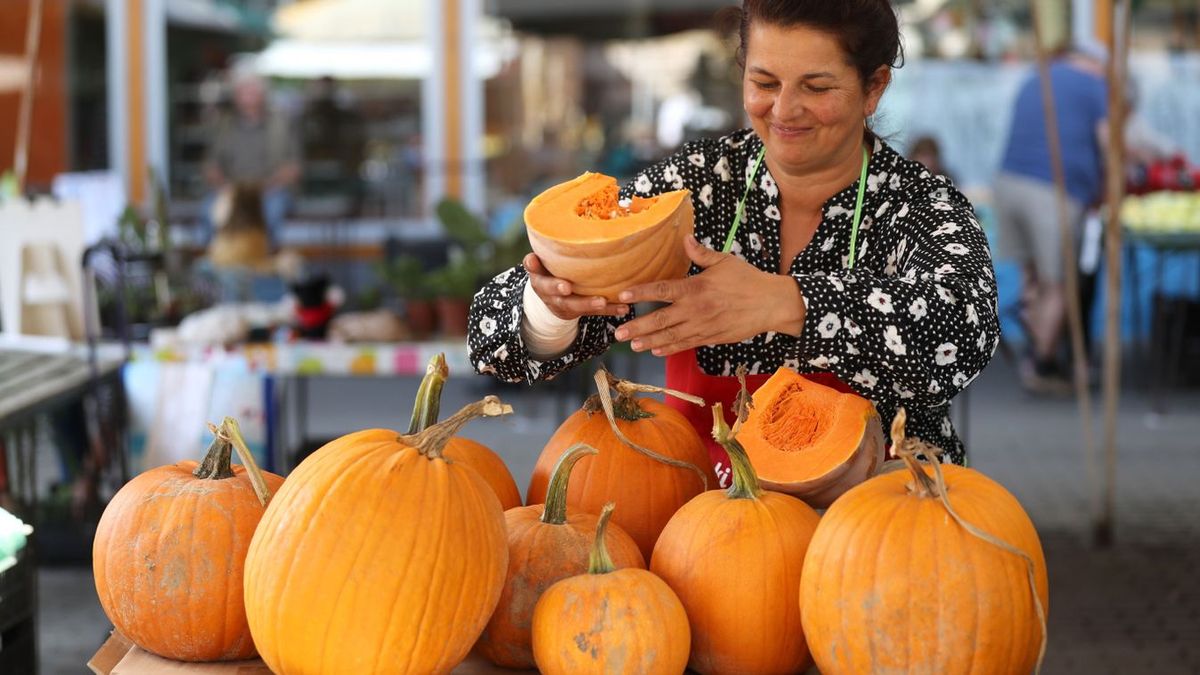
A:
[{"xmin": 800, "ymin": 411, "xmax": 1049, "ymax": 675}]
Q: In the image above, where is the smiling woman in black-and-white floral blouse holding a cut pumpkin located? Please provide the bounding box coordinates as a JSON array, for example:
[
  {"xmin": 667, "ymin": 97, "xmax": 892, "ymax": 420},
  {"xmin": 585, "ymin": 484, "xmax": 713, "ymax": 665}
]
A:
[{"xmin": 469, "ymin": 0, "xmax": 1000, "ymax": 482}]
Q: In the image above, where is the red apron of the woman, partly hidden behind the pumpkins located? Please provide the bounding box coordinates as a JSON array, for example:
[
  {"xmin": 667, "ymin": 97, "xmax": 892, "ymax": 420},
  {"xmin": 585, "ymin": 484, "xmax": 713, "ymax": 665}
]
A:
[{"xmin": 665, "ymin": 350, "xmax": 854, "ymax": 488}]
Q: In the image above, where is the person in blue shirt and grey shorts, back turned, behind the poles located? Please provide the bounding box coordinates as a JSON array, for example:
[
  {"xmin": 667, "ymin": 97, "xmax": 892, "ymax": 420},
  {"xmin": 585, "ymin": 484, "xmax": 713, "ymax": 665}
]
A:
[{"xmin": 995, "ymin": 47, "xmax": 1108, "ymax": 394}]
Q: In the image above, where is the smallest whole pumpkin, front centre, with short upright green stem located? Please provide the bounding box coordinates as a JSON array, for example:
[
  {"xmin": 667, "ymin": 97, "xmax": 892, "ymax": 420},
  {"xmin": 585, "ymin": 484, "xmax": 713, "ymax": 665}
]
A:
[{"xmin": 533, "ymin": 503, "xmax": 690, "ymax": 675}]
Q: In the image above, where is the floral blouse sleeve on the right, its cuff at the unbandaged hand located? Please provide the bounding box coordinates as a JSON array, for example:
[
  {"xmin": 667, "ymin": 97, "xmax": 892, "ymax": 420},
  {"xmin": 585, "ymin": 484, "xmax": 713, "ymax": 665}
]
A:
[{"xmin": 796, "ymin": 192, "xmax": 1000, "ymax": 407}]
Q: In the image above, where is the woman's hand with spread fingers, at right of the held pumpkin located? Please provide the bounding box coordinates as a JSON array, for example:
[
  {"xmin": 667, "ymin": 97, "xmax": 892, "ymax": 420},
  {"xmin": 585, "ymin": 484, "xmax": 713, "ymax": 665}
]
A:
[{"xmin": 616, "ymin": 235, "xmax": 804, "ymax": 357}]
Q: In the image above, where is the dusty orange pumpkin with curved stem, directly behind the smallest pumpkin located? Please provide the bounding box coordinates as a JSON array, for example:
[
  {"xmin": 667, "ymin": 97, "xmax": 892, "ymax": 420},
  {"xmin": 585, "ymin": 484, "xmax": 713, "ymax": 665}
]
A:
[{"xmin": 476, "ymin": 443, "xmax": 646, "ymax": 668}]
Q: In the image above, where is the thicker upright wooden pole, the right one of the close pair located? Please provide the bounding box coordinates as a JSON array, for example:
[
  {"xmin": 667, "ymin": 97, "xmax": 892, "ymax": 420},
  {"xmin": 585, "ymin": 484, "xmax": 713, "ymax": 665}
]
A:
[{"xmin": 1092, "ymin": 0, "xmax": 1133, "ymax": 548}]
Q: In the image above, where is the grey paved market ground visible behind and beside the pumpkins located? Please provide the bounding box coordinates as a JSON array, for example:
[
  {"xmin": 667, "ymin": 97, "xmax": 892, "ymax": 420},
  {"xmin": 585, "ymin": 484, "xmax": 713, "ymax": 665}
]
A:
[{"xmin": 32, "ymin": 348, "xmax": 1200, "ymax": 675}]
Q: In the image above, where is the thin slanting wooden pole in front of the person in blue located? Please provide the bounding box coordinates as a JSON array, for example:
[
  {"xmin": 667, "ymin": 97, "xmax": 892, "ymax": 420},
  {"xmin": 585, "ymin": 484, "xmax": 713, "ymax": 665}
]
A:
[{"xmin": 1032, "ymin": 0, "xmax": 1098, "ymax": 530}]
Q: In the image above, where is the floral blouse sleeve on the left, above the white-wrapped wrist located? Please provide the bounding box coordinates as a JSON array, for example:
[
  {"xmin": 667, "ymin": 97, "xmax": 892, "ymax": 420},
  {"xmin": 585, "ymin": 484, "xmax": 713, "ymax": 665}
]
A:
[{"xmin": 467, "ymin": 144, "xmax": 697, "ymax": 383}]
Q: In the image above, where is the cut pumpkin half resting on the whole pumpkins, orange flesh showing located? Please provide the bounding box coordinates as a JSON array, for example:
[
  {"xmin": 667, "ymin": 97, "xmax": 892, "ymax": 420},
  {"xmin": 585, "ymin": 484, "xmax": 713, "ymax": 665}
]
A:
[{"xmin": 738, "ymin": 368, "xmax": 883, "ymax": 508}]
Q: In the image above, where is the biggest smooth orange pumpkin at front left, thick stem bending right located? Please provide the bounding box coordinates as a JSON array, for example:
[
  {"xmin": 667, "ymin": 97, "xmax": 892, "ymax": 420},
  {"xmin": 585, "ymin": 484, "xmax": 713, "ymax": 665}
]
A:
[{"xmin": 246, "ymin": 396, "xmax": 511, "ymax": 675}]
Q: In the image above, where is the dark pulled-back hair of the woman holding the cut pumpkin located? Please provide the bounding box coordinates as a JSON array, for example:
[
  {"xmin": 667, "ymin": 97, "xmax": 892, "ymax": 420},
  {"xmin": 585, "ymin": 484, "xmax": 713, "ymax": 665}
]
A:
[{"xmin": 722, "ymin": 0, "xmax": 904, "ymax": 89}]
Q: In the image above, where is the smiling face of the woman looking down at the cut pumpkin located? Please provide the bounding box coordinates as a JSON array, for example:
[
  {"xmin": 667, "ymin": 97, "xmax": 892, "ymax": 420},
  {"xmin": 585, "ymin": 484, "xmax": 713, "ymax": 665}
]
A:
[{"xmin": 742, "ymin": 22, "xmax": 890, "ymax": 173}]
